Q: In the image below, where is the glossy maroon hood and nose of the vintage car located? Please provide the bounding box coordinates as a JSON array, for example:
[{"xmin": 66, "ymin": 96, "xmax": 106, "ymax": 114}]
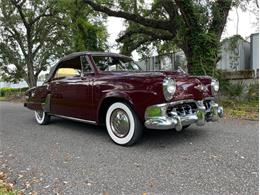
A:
[{"xmin": 99, "ymin": 71, "xmax": 211, "ymax": 101}]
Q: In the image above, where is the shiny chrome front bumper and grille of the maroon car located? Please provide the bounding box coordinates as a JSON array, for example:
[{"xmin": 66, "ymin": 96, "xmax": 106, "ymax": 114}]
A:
[{"xmin": 145, "ymin": 100, "xmax": 224, "ymax": 131}]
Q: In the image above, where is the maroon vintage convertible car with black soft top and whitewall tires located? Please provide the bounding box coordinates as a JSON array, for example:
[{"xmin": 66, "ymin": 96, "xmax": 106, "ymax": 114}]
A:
[{"xmin": 24, "ymin": 52, "xmax": 223, "ymax": 145}]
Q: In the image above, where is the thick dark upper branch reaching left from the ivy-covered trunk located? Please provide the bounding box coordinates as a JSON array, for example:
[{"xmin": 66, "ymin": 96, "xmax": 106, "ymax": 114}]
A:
[{"xmin": 84, "ymin": 0, "xmax": 170, "ymax": 30}]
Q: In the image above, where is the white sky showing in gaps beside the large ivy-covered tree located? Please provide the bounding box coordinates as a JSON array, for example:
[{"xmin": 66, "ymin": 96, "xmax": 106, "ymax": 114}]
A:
[{"xmin": 107, "ymin": 8, "xmax": 259, "ymax": 60}]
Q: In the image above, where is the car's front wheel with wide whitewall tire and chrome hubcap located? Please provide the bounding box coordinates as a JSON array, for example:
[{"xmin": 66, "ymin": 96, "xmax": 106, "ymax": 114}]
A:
[{"xmin": 106, "ymin": 102, "xmax": 143, "ymax": 145}]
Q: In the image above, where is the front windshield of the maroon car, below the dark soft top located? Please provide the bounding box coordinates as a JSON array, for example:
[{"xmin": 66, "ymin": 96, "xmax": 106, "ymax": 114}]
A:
[{"xmin": 92, "ymin": 56, "xmax": 141, "ymax": 71}]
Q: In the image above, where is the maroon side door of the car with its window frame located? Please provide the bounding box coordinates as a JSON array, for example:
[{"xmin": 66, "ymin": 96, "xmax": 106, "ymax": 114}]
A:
[{"xmin": 50, "ymin": 56, "xmax": 92, "ymax": 120}]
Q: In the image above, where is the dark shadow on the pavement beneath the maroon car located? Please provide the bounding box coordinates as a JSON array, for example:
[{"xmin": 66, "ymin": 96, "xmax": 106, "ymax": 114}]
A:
[{"xmin": 47, "ymin": 117, "xmax": 208, "ymax": 147}]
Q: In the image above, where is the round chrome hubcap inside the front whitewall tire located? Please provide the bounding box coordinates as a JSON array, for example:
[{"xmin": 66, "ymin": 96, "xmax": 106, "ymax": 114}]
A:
[{"xmin": 110, "ymin": 109, "xmax": 130, "ymax": 138}]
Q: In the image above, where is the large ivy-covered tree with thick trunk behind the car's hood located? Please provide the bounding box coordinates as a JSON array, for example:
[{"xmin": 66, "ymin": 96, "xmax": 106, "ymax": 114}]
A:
[{"xmin": 84, "ymin": 0, "xmax": 256, "ymax": 75}]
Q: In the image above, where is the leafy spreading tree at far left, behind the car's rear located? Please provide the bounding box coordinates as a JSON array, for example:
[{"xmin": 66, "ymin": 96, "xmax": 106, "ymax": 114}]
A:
[{"xmin": 0, "ymin": 0, "xmax": 66, "ymax": 86}]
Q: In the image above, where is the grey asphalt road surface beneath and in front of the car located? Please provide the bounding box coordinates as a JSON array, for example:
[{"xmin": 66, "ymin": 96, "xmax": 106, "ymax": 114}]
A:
[{"xmin": 0, "ymin": 102, "xmax": 258, "ymax": 195}]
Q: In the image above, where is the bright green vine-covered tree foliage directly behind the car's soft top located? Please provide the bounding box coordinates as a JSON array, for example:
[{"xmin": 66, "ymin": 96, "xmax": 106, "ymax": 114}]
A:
[{"xmin": 58, "ymin": 0, "xmax": 107, "ymax": 52}]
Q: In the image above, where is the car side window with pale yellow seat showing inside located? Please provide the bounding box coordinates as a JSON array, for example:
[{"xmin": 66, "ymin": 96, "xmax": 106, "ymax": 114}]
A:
[{"xmin": 53, "ymin": 57, "xmax": 81, "ymax": 80}]
